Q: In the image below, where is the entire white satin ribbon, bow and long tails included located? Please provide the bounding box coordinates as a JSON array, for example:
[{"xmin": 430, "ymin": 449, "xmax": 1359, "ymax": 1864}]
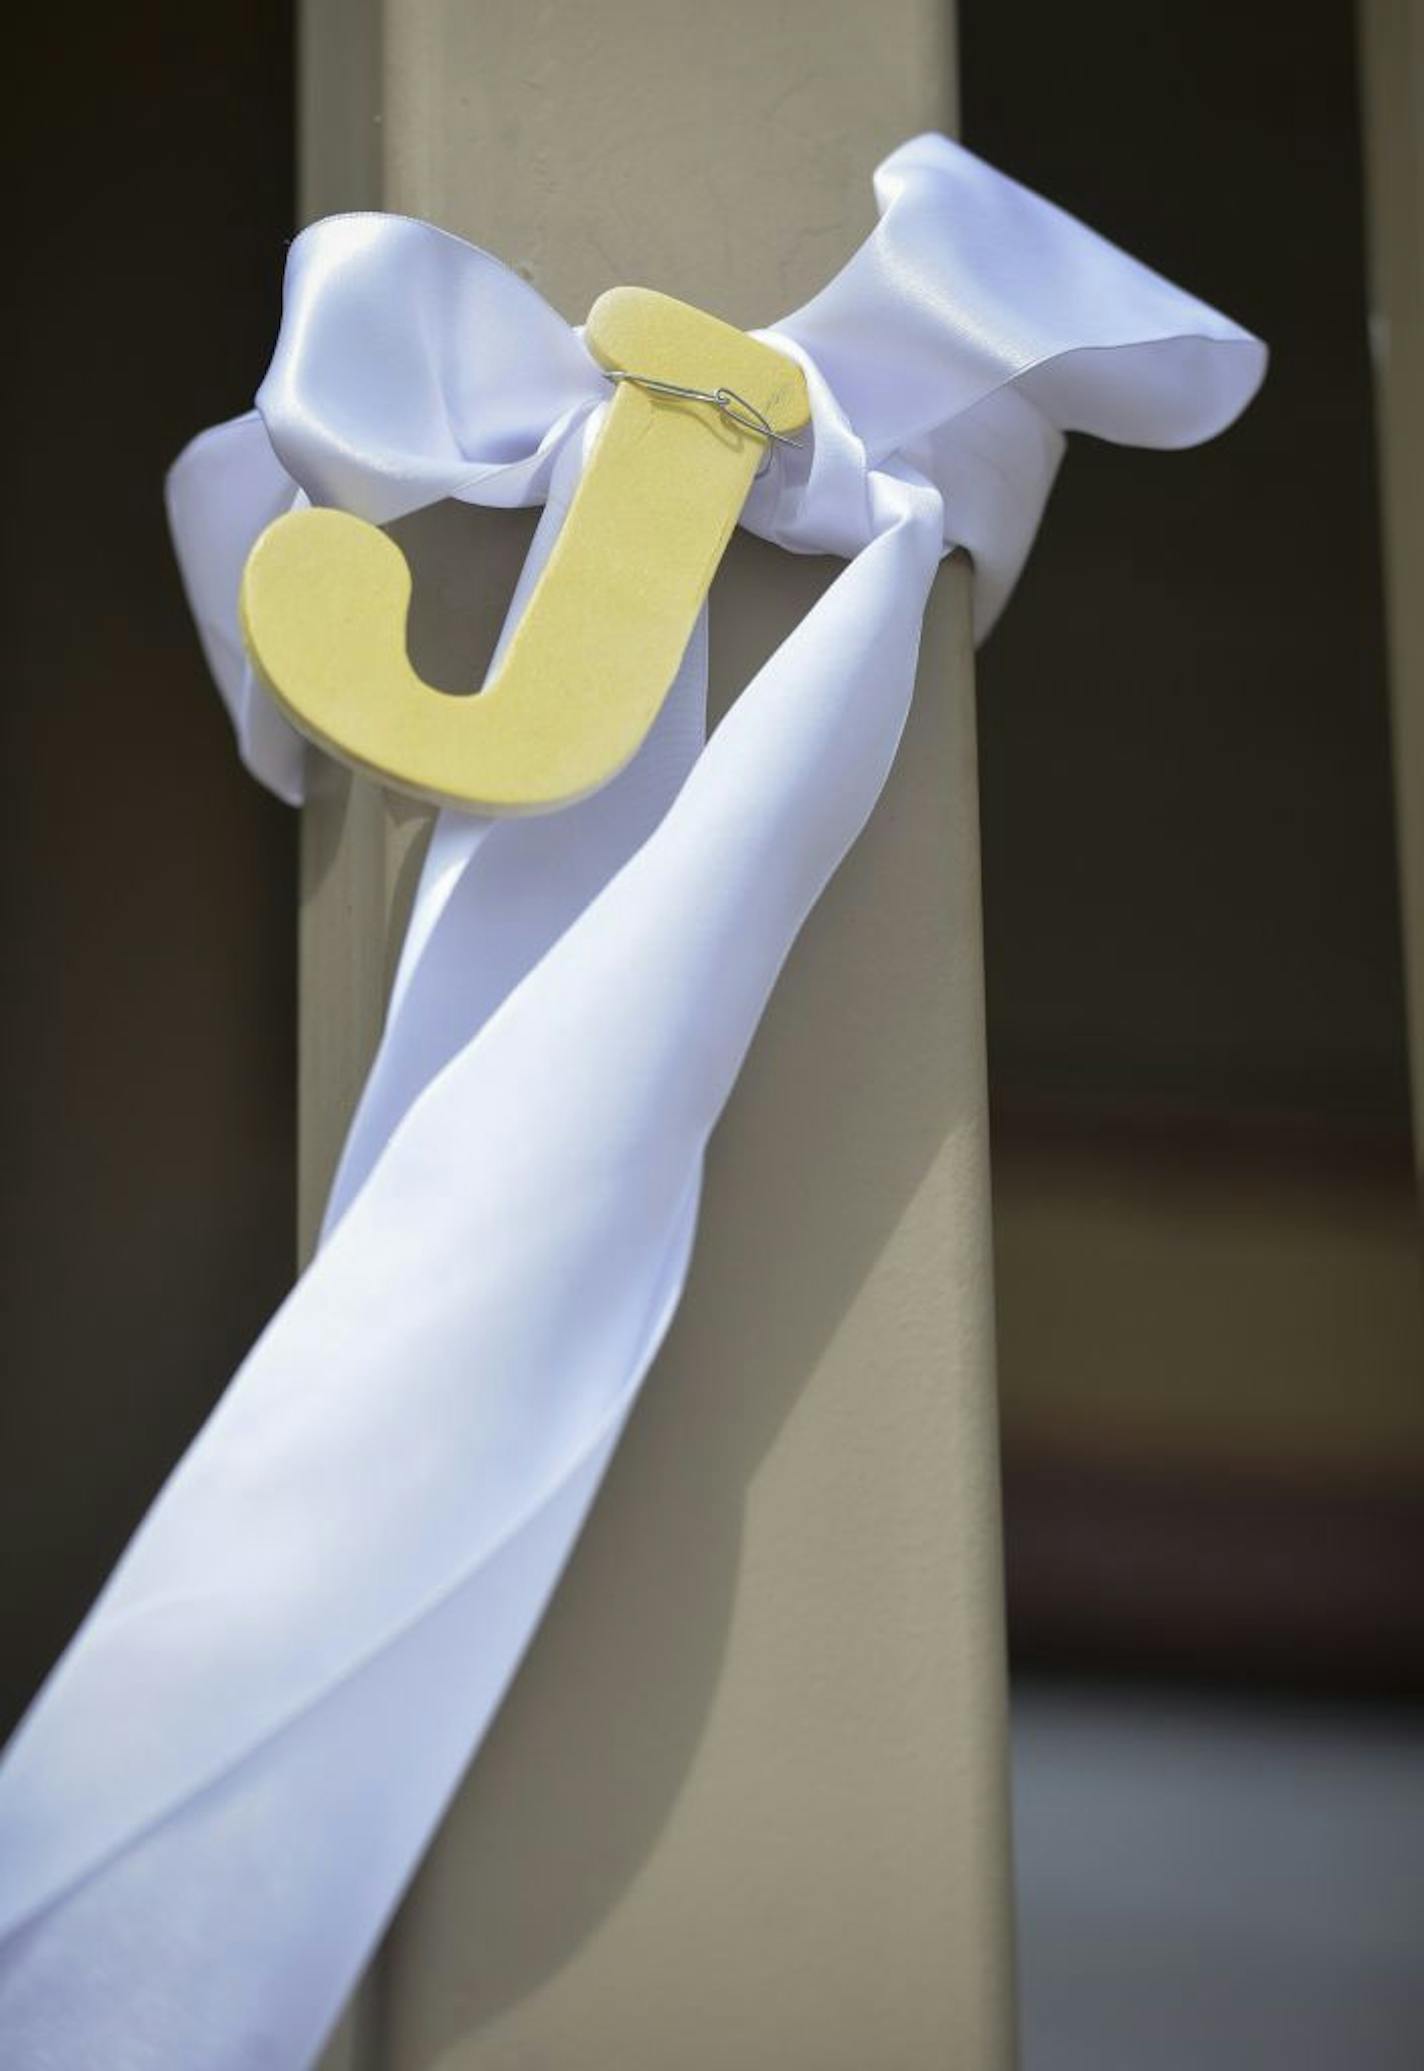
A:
[{"xmin": 0, "ymin": 137, "xmax": 1265, "ymax": 2071}]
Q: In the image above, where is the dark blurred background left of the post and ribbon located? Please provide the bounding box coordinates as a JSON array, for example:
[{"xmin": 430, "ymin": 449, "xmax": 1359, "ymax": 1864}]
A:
[{"xmin": 0, "ymin": 0, "xmax": 296, "ymax": 1725}]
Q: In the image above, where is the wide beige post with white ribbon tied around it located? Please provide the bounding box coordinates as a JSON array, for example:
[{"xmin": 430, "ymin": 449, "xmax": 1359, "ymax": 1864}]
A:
[{"xmin": 302, "ymin": 0, "xmax": 1012, "ymax": 2071}]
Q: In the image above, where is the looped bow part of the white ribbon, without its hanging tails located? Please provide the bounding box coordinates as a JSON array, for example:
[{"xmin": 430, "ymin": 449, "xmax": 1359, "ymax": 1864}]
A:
[{"xmin": 170, "ymin": 135, "xmax": 1265, "ymax": 801}]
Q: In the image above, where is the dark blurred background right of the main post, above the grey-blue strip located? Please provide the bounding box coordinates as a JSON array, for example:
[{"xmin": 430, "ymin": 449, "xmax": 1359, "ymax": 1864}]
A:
[{"xmin": 960, "ymin": 0, "xmax": 1424, "ymax": 1694}]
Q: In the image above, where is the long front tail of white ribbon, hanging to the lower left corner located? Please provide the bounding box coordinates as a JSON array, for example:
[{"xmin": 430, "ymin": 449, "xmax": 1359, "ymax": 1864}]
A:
[{"xmin": 0, "ymin": 480, "xmax": 940, "ymax": 2067}]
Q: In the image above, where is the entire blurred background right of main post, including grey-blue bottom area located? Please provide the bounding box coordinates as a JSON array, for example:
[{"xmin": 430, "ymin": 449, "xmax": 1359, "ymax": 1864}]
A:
[{"xmin": 960, "ymin": 0, "xmax": 1424, "ymax": 2071}]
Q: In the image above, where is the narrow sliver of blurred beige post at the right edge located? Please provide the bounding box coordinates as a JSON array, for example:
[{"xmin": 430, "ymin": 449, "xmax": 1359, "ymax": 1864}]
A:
[{"xmin": 1360, "ymin": 0, "xmax": 1424, "ymax": 1180}]
